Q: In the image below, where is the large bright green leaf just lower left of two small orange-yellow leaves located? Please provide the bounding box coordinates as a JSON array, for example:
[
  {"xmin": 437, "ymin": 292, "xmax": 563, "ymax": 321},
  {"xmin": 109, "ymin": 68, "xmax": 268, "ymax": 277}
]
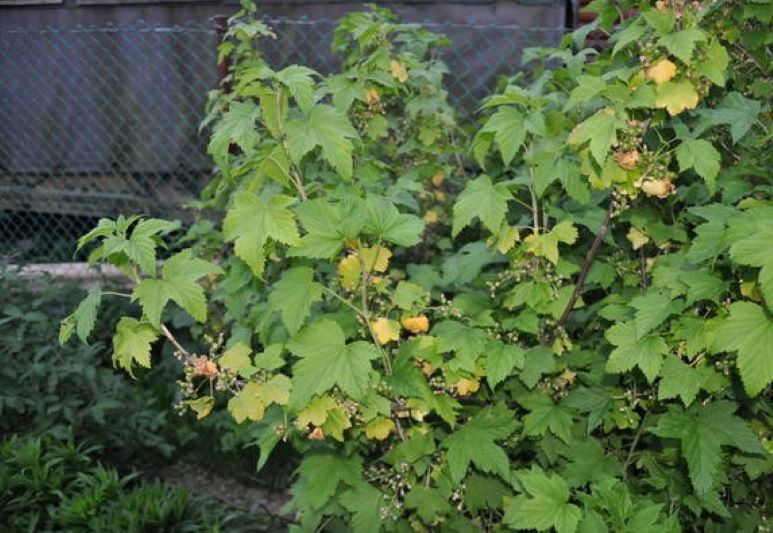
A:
[{"xmin": 287, "ymin": 318, "xmax": 379, "ymax": 407}]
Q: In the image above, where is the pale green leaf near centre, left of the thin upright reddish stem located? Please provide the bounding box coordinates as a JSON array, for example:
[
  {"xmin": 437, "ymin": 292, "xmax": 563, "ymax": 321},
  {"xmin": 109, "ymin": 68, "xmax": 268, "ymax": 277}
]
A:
[{"xmin": 451, "ymin": 175, "xmax": 512, "ymax": 237}]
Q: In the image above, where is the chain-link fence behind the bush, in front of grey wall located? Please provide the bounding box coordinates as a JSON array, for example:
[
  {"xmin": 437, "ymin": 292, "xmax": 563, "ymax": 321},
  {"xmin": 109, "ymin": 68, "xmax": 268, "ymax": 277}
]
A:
[{"xmin": 0, "ymin": 19, "xmax": 563, "ymax": 262}]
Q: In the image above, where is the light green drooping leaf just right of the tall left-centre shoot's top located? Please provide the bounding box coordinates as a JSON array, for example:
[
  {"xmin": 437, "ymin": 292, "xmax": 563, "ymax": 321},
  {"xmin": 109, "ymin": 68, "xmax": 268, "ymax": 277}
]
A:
[{"xmin": 285, "ymin": 104, "xmax": 358, "ymax": 178}]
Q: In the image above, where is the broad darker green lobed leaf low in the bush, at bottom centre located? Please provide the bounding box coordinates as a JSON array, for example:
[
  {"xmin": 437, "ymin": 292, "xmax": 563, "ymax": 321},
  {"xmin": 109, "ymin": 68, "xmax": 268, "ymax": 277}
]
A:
[{"xmin": 443, "ymin": 405, "xmax": 518, "ymax": 483}]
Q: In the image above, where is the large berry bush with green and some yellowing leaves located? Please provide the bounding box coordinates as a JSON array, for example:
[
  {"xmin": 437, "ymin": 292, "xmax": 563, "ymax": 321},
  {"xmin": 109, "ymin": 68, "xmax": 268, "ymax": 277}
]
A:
[{"xmin": 61, "ymin": 0, "xmax": 773, "ymax": 533}]
